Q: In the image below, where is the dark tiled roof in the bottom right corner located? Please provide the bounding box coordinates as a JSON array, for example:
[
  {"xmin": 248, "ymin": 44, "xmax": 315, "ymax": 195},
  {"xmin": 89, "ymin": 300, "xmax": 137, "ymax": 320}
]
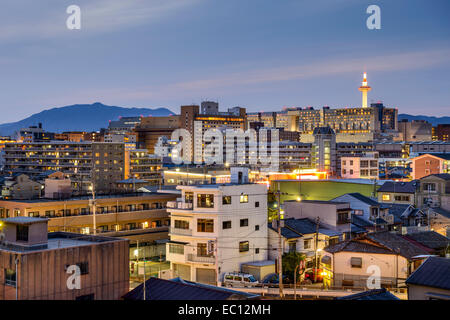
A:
[{"xmin": 406, "ymin": 257, "xmax": 450, "ymax": 290}]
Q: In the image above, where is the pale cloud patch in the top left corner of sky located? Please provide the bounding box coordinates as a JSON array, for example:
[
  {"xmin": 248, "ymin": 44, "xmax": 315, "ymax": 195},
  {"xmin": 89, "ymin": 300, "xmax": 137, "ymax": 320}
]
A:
[{"xmin": 0, "ymin": 0, "xmax": 204, "ymax": 41}]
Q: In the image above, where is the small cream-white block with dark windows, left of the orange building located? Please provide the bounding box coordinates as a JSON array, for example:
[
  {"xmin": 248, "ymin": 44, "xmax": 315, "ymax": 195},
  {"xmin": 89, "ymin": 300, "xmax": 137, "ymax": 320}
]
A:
[{"xmin": 341, "ymin": 152, "xmax": 379, "ymax": 180}]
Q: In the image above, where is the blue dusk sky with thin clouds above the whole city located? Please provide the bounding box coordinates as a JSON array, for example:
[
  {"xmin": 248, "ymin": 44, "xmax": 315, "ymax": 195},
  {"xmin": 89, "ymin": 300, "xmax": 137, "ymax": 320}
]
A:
[{"xmin": 0, "ymin": 0, "xmax": 450, "ymax": 123}]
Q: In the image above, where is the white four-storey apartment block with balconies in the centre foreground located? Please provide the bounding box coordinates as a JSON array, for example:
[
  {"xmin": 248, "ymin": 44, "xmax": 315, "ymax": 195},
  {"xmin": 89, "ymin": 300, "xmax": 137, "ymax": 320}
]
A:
[{"xmin": 166, "ymin": 178, "xmax": 268, "ymax": 284}]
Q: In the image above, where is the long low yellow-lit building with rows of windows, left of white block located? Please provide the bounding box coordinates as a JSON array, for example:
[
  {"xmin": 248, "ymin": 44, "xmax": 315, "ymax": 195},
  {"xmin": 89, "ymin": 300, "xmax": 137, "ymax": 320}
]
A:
[{"xmin": 0, "ymin": 193, "xmax": 177, "ymax": 240}]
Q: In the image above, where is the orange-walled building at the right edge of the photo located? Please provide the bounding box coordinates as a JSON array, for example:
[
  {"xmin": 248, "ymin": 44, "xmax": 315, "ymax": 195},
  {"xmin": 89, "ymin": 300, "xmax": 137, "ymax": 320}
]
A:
[{"xmin": 411, "ymin": 153, "xmax": 450, "ymax": 180}]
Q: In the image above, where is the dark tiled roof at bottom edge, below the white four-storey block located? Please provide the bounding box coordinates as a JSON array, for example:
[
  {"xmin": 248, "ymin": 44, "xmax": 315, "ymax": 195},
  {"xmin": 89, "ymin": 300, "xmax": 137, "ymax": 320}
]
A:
[{"xmin": 123, "ymin": 277, "xmax": 258, "ymax": 300}]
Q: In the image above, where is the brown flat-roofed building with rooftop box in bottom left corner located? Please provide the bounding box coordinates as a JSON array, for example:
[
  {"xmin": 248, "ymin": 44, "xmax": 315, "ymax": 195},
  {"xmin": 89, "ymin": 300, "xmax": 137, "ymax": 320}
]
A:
[{"xmin": 0, "ymin": 217, "xmax": 129, "ymax": 300}]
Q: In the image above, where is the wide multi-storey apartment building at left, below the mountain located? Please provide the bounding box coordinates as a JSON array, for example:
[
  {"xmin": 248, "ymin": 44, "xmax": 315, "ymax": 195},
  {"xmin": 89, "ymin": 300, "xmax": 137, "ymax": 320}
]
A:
[{"xmin": 4, "ymin": 141, "xmax": 125, "ymax": 194}]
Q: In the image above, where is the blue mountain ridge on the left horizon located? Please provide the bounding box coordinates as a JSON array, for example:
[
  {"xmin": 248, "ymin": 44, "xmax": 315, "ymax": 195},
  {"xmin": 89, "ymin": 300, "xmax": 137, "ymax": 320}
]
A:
[{"xmin": 0, "ymin": 102, "xmax": 174, "ymax": 135}]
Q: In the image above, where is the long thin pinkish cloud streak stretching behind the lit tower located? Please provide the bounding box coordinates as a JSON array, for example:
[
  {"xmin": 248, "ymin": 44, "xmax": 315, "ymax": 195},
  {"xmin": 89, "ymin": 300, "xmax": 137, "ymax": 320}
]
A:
[{"xmin": 54, "ymin": 45, "xmax": 450, "ymax": 101}]
